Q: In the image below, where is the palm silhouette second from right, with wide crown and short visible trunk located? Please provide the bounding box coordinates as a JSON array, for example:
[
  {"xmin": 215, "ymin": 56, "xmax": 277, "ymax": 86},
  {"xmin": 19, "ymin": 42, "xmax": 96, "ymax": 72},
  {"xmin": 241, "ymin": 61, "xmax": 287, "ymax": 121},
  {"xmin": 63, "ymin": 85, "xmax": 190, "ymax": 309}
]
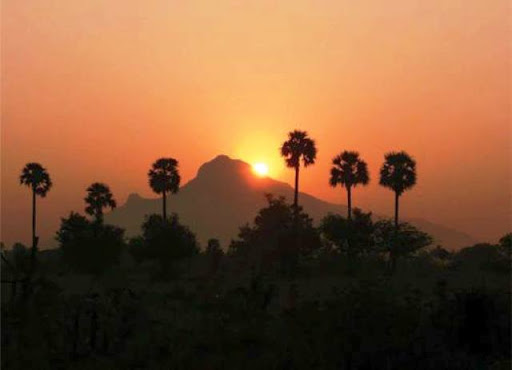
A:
[{"xmin": 329, "ymin": 150, "xmax": 370, "ymax": 220}]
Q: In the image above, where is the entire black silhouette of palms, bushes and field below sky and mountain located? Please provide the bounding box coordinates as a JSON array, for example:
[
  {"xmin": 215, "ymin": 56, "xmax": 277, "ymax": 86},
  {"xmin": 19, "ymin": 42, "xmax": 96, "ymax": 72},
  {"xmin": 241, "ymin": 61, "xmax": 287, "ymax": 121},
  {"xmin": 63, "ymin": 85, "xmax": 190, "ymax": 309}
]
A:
[{"xmin": 1, "ymin": 131, "xmax": 512, "ymax": 369}]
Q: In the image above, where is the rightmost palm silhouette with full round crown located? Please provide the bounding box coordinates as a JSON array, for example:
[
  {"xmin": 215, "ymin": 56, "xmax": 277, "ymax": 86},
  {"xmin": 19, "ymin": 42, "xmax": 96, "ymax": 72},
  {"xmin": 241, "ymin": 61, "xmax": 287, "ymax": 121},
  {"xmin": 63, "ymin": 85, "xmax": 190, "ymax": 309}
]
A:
[{"xmin": 380, "ymin": 151, "xmax": 416, "ymax": 228}]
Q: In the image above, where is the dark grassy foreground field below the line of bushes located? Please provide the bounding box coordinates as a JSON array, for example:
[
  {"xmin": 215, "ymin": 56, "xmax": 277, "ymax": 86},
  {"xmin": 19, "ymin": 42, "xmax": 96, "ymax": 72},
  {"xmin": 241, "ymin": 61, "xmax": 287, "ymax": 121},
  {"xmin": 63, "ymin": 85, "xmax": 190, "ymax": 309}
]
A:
[{"xmin": 2, "ymin": 246, "xmax": 511, "ymax": 369}]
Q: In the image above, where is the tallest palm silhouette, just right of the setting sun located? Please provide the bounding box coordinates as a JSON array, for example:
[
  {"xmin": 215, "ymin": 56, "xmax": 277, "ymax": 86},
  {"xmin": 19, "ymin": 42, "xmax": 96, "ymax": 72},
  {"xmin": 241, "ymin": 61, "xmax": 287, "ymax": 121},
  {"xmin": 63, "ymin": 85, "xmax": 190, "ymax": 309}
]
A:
[{"xmin": 281, "ymin": 130, "xmax": 316, "ymax": 210}]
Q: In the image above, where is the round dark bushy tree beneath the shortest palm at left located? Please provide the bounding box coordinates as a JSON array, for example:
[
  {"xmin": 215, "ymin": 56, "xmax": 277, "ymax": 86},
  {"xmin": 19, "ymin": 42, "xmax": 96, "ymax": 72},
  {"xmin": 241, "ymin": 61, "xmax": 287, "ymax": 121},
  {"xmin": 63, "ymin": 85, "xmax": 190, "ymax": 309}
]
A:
[{"xmin": 57, "ymin": 212, "xmax": 124, "ymax": 274}]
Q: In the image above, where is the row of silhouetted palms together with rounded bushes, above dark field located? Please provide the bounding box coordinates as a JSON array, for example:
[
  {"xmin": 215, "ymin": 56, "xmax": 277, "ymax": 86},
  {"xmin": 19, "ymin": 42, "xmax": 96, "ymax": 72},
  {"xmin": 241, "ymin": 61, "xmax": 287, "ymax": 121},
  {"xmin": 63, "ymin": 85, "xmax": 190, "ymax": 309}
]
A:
[{"xmin": 6, "ymin": 130, "xmax": 510, "ymax": 285}]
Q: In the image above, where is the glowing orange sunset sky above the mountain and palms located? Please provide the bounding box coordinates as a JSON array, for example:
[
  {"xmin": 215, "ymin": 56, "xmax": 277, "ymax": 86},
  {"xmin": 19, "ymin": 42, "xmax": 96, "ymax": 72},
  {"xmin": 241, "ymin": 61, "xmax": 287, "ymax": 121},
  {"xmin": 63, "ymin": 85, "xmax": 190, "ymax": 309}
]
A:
[{"xmin": 1, "ymin": 0, "xmax": 512, "ymax": 249}]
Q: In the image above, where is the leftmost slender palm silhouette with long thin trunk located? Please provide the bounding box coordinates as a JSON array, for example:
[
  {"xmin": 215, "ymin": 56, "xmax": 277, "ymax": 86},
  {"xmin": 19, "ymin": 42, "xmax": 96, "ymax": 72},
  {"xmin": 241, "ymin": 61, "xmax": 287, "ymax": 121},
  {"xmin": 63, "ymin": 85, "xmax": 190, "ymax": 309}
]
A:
[{"xmin": 20, "ymin": 162, "xmax": 52, "ymax": 269}]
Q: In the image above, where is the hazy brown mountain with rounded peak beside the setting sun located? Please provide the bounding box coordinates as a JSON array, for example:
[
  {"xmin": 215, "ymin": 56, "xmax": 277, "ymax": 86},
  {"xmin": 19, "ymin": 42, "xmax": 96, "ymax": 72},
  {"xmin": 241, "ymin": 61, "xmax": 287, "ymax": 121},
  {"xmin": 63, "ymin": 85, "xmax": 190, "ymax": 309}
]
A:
[{"xmin": 105, "ymin": 155, "xmax": 475, "ymax": 249}]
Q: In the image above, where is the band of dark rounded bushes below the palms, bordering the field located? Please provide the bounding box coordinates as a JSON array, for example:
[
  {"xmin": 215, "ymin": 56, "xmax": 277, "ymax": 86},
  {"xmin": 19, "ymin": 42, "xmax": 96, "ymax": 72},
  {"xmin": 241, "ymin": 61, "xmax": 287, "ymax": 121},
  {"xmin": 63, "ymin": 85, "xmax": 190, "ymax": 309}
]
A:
[{"xmin": 2, "ymin": 194, "xmax": 512, "ymax": 277}]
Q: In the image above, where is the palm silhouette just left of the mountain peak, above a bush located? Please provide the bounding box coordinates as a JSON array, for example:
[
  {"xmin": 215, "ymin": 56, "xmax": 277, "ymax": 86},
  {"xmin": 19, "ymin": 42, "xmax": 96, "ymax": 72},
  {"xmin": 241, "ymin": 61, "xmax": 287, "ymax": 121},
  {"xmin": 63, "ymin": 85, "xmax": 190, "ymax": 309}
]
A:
[{"xmin": 148, "ymin": 158, "xmax": 181, "ymax": 220}]
